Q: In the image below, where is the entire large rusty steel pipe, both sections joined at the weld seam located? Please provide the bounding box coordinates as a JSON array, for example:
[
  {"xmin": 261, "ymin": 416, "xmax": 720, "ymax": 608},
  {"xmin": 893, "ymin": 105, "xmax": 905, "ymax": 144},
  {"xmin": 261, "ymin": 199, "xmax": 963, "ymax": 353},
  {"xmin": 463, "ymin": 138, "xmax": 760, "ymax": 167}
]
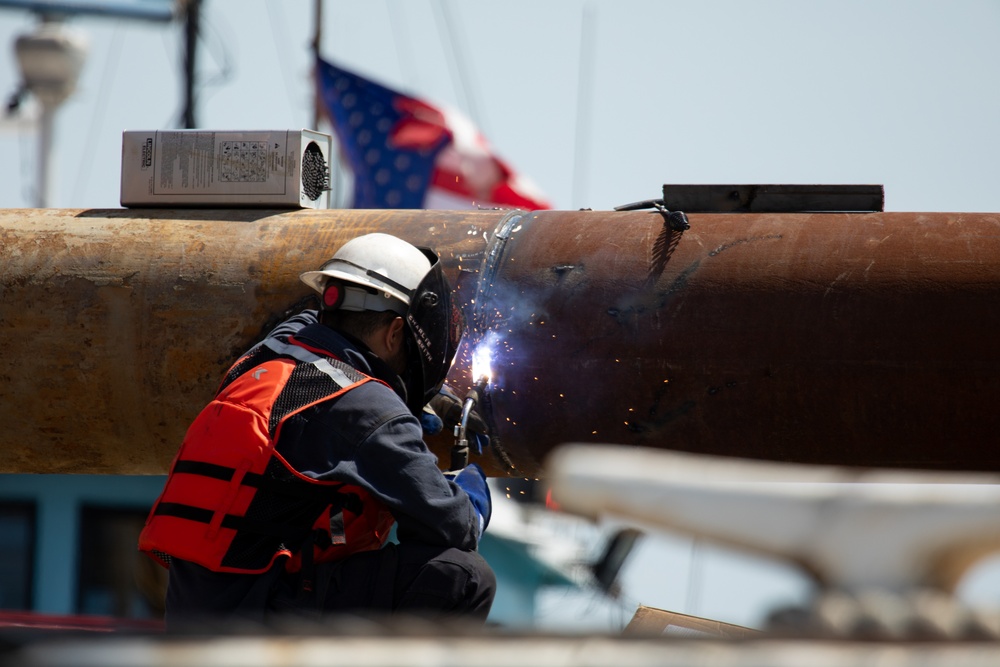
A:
[{"xmin": 0, "ymin": 210, "xmax": 1000, "ymax": 476}]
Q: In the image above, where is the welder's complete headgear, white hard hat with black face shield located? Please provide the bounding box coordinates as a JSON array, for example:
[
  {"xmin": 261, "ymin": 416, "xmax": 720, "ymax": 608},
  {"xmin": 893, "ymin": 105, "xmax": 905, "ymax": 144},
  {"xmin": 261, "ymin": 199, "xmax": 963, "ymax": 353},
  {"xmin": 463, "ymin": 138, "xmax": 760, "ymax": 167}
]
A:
[{"xmin": 300, "ymin": 233, "xmax": 465, "ymax": 414}]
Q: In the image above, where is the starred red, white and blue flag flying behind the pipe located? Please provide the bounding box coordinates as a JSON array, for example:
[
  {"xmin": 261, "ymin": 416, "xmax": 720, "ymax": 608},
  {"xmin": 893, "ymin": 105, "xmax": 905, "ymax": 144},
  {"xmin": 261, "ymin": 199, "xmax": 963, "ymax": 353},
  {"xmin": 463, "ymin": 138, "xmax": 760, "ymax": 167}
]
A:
[{"xmin": 316, "ymin": 58, "xmax": 551, "ymax": 210}]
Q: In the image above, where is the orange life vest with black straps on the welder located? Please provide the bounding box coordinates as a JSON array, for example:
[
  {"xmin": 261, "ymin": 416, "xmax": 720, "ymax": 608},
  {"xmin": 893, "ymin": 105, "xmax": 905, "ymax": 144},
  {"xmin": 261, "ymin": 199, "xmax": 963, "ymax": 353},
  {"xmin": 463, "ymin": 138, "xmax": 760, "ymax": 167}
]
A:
[{"xmin": 139, "ymin": 338, "xmax": 394, "ymax": 573}]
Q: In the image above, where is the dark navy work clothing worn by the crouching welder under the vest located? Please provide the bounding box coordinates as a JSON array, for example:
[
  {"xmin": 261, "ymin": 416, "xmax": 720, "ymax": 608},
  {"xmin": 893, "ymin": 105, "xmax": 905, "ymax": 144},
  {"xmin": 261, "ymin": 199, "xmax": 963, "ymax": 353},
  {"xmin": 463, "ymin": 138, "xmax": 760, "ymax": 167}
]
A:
[{"xmin": 166, "ymin": 311, "xmax": 496, "ymax": 629}]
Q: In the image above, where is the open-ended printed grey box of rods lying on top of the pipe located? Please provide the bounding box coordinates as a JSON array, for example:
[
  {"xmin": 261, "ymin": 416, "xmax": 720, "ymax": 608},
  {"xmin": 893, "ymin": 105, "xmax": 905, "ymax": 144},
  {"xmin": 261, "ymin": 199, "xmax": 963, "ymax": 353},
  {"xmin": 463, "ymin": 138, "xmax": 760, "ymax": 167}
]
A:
[{"xmin": 121, "ymin": 130, "xmax": 333, "ymax": 209}]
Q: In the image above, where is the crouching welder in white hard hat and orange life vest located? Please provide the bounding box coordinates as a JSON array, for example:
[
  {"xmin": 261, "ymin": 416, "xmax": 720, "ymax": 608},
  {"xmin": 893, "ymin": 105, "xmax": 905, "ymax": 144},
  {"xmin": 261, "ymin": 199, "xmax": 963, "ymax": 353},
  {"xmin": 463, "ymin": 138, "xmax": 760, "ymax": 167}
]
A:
[{"xmin": 139, "ymin": 234, "xmax": 496, "ymax": 629}]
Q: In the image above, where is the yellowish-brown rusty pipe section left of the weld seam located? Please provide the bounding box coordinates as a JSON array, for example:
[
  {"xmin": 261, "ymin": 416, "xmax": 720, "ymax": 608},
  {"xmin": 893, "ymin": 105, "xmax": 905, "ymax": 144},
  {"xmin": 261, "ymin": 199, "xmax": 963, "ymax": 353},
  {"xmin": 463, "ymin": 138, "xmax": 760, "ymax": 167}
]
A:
[{"xmin": 0, "ymin": 209, "xmax": 505, "ymax": 474}]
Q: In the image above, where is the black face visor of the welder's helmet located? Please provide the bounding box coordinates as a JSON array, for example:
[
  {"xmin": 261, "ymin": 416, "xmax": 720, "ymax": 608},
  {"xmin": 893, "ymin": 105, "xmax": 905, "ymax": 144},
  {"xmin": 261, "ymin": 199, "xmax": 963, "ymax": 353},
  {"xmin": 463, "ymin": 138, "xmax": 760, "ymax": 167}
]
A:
[{"xmin": 404, "ymin": 254, "xmax": 465, "ymax": 414}]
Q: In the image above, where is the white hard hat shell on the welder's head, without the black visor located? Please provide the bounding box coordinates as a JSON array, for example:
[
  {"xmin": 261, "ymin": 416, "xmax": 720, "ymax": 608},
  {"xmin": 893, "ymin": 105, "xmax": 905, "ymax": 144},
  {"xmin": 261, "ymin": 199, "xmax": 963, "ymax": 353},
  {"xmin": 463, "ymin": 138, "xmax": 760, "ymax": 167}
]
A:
[{"xmin": 299, "ymin": 233, "xmax": 437, "ymax": 315}]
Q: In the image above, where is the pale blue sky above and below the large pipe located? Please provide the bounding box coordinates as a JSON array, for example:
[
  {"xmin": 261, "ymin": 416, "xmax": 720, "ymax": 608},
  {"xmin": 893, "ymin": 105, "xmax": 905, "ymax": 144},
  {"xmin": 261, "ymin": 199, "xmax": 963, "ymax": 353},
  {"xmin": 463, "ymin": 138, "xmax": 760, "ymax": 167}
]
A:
[{"xmin": 0, "ymin": 0, "xmax": 1000, "ymax": 624}]
